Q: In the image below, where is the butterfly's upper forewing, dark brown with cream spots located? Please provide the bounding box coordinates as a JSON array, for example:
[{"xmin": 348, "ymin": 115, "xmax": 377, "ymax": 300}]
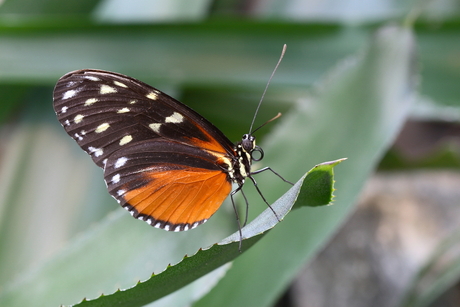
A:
[{"xmin": 54, "ymin": 70, "xmax": 233, "ymax": 167}]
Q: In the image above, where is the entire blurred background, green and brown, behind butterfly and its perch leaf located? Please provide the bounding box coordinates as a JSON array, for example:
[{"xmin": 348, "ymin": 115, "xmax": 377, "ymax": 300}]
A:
[{"xmin": 0, "ymin": 0, "xmax": 460, "ymax": 307}]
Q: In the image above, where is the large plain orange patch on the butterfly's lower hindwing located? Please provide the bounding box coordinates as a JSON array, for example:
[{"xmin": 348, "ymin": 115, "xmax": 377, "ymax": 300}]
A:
[{"xmin": 124, "ymin": 168, "xmax": 231, "ymax": 229}]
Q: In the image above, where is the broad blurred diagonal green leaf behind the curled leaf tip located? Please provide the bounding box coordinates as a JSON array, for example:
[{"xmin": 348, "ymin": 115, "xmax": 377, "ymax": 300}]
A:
[{"xmin": 194, "ymin": 27, "xmax": 416, "ymax": 307}]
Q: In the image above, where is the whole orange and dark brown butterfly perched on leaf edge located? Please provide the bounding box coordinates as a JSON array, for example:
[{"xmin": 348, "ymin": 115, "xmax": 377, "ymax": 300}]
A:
[{"xmin": 53, "ymin": 45, "xmax": 288, "ymax": 250}]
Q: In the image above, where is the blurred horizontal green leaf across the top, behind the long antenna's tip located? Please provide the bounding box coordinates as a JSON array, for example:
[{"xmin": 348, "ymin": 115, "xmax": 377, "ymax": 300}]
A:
[{"xmin": 0, "ymin": 19, "xmax": 366, "ymax": 88}]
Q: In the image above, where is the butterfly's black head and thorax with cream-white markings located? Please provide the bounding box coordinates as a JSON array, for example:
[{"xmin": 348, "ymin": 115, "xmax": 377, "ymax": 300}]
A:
[{"xmin": 229, "ymin": 134, "xmax": 263, "ymax": 185}]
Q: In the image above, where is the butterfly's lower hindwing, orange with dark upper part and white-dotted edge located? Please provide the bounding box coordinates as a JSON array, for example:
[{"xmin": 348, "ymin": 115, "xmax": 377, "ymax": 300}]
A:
[{"xmin": 104, "ymin": 140, "xmax": 231, "ymax": 231}]
